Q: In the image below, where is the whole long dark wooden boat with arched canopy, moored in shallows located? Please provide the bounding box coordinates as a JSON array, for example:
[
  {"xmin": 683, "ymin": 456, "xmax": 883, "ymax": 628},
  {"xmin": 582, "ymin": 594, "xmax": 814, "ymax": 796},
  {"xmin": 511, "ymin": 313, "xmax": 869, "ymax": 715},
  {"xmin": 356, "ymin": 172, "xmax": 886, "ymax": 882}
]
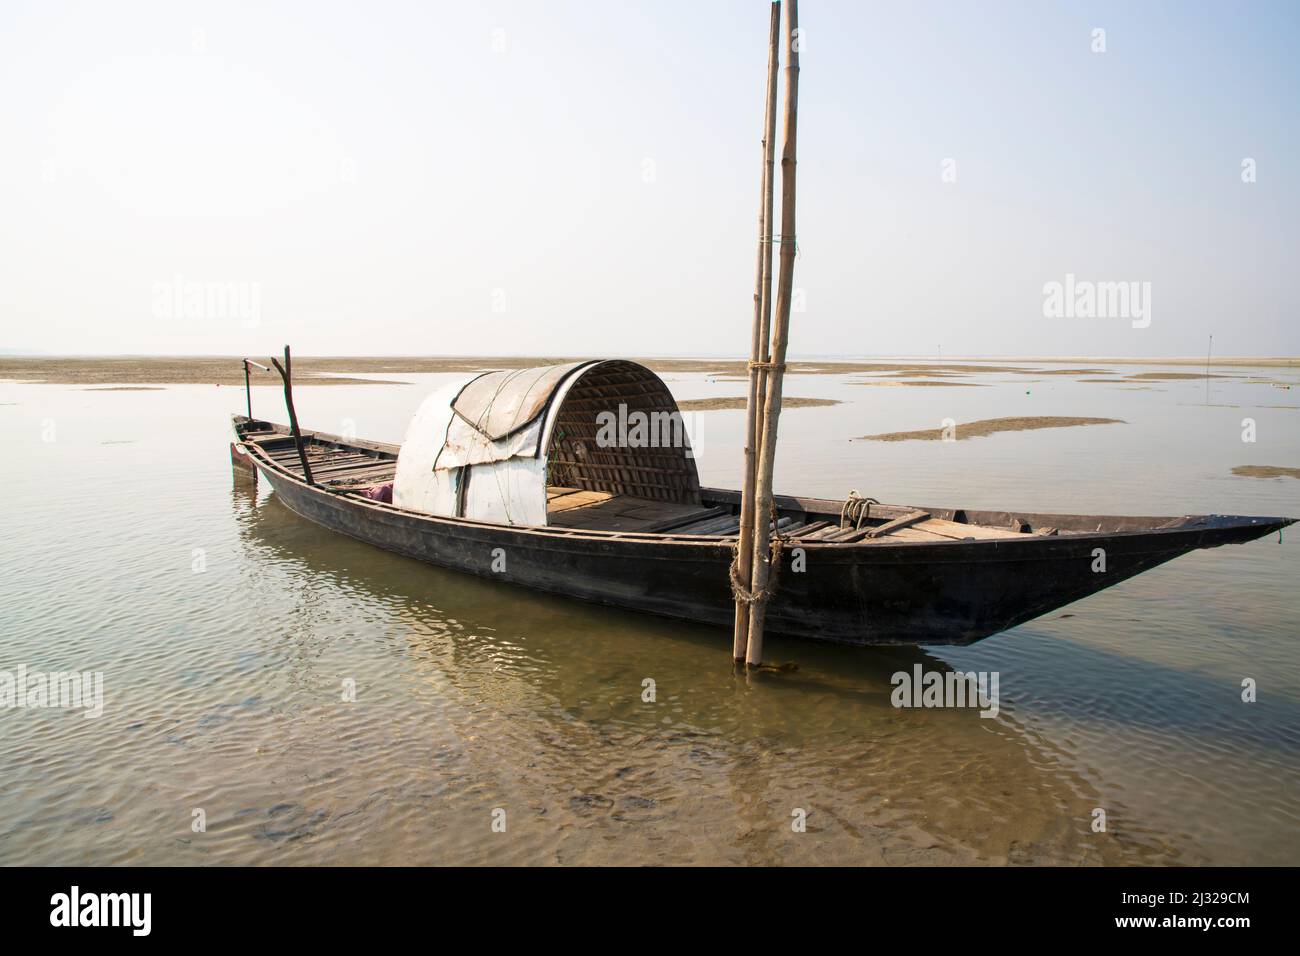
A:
[{"xmin": 231, "ymin": 362, "xmax": 1294, "ymax": 645}]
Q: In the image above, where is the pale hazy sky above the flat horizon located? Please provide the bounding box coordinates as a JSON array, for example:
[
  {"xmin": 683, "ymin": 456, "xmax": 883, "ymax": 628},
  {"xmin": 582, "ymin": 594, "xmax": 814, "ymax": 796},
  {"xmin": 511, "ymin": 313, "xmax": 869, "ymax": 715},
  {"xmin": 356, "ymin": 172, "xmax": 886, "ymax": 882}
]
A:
[{"xmin": 0, "ymin": 0, "xmax": 1300, "ymax": 355}]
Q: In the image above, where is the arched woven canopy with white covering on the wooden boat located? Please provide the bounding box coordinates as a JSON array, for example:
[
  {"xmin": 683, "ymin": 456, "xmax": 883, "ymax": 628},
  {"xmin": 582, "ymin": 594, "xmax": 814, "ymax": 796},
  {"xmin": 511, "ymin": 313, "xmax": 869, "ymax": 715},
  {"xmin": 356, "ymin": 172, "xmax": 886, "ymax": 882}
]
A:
[{"xmin": 393, "ymin": 359, "xmax": 699, "ymax": 525}]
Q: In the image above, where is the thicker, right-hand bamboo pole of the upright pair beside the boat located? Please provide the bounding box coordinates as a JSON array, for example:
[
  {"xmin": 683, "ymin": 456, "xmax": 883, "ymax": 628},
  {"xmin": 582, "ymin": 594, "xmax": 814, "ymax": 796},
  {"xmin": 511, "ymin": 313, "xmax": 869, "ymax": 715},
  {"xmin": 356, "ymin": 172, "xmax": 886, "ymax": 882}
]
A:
[{"xmin": 745, "ymin": 0, "xmax": 800, "ymax": 666}]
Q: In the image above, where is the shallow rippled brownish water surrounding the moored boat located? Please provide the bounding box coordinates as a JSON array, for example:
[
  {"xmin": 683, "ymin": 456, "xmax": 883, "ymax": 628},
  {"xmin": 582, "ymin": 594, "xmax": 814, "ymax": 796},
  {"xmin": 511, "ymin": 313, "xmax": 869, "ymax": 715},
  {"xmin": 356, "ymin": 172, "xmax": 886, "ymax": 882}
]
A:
[{"xmin": 0, "ymin": 367, "xmax": 1300, "ymax": 865}]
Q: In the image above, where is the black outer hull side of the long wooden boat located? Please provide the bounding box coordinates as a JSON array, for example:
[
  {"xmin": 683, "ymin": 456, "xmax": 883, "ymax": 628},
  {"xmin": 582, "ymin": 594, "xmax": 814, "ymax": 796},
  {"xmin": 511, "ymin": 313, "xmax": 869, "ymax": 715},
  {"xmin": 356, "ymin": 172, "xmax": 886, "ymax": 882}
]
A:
[{"xmin": 248, "ymin": 452, "xmax": 1290, "ymax": 645}]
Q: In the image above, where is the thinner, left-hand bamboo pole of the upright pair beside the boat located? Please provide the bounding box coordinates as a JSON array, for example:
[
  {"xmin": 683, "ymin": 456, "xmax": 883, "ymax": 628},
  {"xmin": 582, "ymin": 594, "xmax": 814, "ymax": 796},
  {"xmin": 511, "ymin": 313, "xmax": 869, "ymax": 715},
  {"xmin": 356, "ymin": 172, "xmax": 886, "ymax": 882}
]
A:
[{"xmin": 732, "ymin": 0, "xmax": 781, "ymax": 661}]
